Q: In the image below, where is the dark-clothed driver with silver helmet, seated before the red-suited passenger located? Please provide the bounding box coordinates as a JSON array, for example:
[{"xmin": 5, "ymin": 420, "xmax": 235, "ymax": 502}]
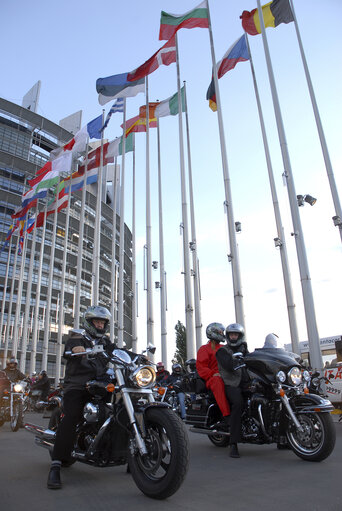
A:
[{"xmin": 216, "ymin": 323, "xmax": 248, "ymax": 458}]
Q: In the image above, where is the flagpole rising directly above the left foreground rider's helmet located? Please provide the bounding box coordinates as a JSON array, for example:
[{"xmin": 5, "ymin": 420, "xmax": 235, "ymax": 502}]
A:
[{"xmin": 92, "ymin": 109, "xmax": 105, "ymax": 305}]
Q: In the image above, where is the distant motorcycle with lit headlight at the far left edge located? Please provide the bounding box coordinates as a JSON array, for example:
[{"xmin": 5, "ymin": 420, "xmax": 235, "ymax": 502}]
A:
[{"xmin": 0, "ymin": 382, "xmax": 25, "ymax": 432}]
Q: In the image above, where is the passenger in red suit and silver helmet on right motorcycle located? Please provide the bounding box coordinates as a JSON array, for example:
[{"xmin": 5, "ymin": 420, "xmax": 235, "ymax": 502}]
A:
[{"xmin": 196, "ymin": 323, "xmax": 230, "ymax": 428}]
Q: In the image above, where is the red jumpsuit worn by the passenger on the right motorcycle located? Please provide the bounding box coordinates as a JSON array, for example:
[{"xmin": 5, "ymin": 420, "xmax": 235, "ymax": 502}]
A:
[{"xmin": 196, "ymin": 341, "xmax": 230, "ymax": 417}]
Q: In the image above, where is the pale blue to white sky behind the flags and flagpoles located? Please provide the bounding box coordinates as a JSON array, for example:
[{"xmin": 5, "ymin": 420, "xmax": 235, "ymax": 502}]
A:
[{"xmin": 0, "ymin": 0, "xmax": 342, "ymax": 363}]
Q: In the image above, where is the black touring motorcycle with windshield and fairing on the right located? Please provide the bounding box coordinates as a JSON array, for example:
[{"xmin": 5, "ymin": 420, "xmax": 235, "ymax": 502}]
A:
[{"xmin": 186, "ymin": 348, "xmax": 336, "ymax": 461}]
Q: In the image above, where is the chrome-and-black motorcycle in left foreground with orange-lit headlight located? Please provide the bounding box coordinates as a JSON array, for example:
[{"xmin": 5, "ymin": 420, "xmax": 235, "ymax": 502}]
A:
[{"xmin": 25, "ymin": 346, "xmax": 189, "ymax": 499}]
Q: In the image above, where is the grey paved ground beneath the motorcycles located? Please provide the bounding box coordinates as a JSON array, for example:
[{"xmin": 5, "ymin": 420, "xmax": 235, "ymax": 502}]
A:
[{"xmin": 0, "ymin": 414, "xmax": 342, "ymax": 511}]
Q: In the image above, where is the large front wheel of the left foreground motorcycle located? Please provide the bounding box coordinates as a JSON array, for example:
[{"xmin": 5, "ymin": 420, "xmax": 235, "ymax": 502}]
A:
[{"xmin": 128, "ymin": 408, "xmax": 189, "ymax": 500}]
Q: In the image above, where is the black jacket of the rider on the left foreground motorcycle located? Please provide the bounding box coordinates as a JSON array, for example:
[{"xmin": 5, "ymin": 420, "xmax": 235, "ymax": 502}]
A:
[{"xmin": 63, "ymin": 330, "xmax": 115, "ymax": 393}]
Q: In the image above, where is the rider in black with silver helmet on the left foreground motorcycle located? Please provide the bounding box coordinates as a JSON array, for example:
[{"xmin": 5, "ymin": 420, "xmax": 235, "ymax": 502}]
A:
[{"xmin": 47, "ymin": 306, "xmax": 115, "ymax": 489}]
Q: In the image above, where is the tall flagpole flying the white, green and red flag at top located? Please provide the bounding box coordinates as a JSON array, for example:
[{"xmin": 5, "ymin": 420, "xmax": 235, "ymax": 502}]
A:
[{"xmin": 207, "ymin": 0, "xmax": 245, "ymax": 326}]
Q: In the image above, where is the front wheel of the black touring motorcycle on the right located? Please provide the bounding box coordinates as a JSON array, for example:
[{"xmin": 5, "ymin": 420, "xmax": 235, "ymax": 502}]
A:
[{"xmin": 287, "ymin": 412, "xmax": 336, "ymax": 461}]
